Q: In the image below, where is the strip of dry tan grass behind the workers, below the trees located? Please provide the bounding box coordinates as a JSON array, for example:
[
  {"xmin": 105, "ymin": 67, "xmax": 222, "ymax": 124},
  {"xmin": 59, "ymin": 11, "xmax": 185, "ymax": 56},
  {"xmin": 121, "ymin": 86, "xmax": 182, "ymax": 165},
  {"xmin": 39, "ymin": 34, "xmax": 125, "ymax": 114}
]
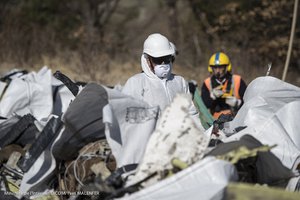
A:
[{"xmin": 0, "ymin": 53, "xmax": 300, "ymax": 86}]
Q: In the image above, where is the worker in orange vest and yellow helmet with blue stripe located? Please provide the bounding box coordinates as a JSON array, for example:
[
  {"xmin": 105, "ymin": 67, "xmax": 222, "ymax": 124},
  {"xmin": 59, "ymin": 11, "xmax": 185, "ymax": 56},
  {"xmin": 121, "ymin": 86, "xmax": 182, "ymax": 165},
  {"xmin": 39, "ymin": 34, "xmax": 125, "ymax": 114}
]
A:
[{"xmin": 201, "ymin": 52, "xmax": 247, "ymax": 119}]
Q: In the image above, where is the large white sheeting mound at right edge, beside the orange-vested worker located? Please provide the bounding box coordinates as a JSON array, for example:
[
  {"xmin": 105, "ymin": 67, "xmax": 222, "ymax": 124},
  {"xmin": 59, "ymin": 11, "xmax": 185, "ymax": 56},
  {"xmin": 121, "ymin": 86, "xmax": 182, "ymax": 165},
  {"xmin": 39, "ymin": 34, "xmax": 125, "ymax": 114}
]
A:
[{"xmin": 223, "ymin": 76, "xmax": 300, "ymax": 169}]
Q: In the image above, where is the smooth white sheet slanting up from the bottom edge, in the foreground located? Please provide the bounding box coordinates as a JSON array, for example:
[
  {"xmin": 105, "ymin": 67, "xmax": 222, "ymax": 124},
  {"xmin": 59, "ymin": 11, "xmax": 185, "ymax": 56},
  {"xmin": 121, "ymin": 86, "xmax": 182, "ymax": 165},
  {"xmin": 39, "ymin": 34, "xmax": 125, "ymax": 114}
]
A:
[{"xmin": 119, "ymin": 157, "xmax": 238, "ymax": 200}]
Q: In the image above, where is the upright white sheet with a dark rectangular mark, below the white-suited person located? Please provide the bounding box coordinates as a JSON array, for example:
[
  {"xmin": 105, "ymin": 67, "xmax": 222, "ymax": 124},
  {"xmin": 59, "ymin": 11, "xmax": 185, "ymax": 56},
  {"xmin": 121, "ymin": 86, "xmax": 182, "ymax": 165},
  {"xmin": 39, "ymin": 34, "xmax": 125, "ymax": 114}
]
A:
[{"xmin": 103, "ymin": 88, "xmax": 159, "ymax": 167}]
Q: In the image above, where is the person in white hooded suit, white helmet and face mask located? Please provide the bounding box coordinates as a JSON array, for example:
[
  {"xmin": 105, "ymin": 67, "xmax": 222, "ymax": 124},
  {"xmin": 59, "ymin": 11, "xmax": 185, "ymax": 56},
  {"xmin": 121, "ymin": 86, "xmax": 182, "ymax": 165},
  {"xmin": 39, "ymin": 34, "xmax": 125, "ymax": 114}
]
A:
[{"xmin": 122, "ymin": 33, "xmax": 204, "ymax": 131}]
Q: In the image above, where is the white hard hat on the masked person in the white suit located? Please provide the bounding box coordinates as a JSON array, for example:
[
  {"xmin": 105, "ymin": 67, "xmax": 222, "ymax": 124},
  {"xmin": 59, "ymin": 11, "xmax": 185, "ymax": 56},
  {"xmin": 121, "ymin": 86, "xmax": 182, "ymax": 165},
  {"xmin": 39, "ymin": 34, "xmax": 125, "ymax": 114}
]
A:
[{"xmin": 143, "ymin": 33, "xmax": 175, "ymax": 58}]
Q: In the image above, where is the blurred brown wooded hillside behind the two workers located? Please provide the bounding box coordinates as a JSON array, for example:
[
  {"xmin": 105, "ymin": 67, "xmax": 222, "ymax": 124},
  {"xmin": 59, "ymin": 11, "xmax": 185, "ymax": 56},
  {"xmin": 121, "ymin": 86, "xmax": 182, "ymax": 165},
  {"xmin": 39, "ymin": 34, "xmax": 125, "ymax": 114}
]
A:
[{"xmin": 0, "ymin": 0, "xmax": 300, "ymax": 86}]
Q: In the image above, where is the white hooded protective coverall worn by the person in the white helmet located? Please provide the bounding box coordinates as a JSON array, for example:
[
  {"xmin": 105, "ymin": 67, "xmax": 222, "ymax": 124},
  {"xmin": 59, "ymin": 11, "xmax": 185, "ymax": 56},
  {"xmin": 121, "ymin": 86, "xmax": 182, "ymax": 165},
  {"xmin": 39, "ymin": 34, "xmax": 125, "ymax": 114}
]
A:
[{"xmin": 122, "ymin": 54, "xmax": 204, "ymax": 131}]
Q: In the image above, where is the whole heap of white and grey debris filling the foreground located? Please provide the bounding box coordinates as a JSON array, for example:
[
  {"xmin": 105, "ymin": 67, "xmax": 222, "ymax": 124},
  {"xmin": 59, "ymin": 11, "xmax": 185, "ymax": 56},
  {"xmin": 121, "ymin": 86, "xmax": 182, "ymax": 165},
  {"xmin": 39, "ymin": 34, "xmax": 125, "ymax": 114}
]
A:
[{"xmin": 0, "ymin": 67, "xmax": 300, "ymax": 200}]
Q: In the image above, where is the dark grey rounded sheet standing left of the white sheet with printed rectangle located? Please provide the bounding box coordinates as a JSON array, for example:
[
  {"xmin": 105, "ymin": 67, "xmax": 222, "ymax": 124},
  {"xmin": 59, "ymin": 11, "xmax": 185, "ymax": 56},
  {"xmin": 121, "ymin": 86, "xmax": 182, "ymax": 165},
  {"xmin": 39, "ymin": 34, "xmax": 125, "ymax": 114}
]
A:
[{"xmin": 53, "ymin": 83, "xmax": 108, "ymax": 160}]
